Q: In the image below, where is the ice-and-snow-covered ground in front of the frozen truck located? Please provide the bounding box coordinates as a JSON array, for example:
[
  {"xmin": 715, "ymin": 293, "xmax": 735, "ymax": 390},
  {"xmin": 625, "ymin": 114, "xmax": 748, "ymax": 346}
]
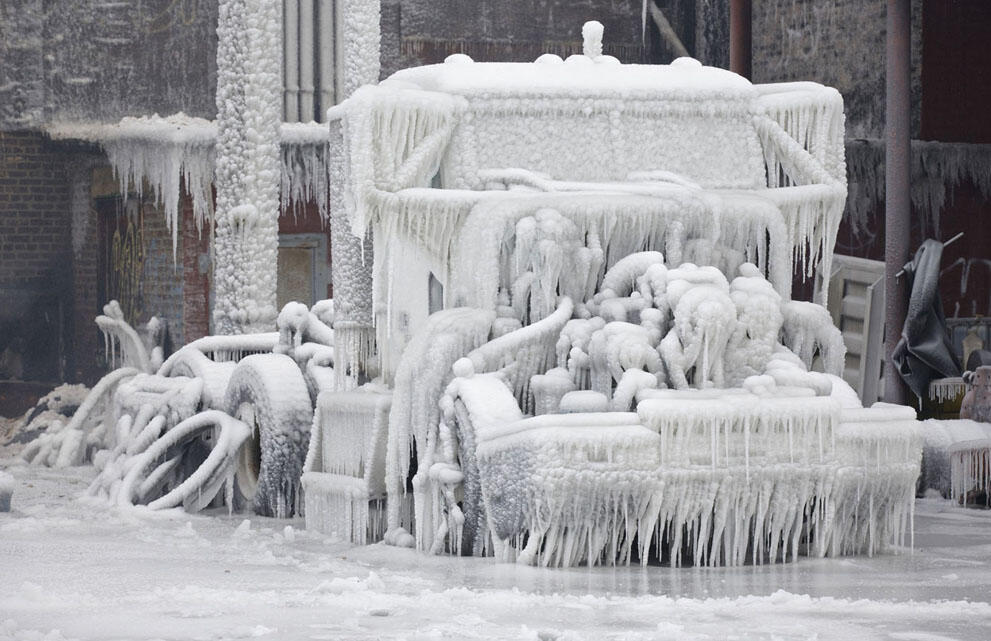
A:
[{"xmin": 0, "ymin": 449, "xmax": 991, "ymax": 641}]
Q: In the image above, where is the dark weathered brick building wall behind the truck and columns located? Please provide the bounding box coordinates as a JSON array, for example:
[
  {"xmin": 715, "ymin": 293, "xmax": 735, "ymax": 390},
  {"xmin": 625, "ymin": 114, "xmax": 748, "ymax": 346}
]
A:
[{"xmin": 0, "ymin": 0, "xmax": 991, "ymax": 413}]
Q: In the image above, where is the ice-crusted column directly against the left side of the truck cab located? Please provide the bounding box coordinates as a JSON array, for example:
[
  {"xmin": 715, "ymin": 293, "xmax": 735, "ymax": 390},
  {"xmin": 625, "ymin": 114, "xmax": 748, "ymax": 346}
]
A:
[{"xmin": 328, "ymin": 0, "xmax": 381, "ymax": 388}]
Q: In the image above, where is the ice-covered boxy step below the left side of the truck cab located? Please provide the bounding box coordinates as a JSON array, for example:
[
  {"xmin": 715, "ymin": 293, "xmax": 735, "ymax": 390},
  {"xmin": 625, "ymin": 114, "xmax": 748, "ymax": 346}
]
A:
[{"xmin": 302, "ymin": 390, "xmax": 392, "ymax": 545}]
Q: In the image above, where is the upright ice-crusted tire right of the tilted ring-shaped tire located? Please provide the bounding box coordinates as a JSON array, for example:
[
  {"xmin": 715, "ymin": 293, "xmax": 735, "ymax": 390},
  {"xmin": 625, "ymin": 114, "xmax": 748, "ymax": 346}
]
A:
[{"xmin": 224, "ymin": 354, "xmax": 313, "ymax": 518}]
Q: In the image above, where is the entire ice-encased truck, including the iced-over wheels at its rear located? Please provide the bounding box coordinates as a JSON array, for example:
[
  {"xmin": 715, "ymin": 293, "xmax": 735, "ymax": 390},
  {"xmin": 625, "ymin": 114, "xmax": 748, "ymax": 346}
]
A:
[{"xmin": 36, "ymin": 23, "xmax": 921, "ymax": 565}]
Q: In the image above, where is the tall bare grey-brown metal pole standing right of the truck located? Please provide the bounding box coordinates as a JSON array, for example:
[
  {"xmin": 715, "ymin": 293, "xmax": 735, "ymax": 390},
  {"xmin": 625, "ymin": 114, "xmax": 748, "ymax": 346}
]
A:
[{"xmin": 884, "ymin": 0, "xmax": 912, "ymax": 403}]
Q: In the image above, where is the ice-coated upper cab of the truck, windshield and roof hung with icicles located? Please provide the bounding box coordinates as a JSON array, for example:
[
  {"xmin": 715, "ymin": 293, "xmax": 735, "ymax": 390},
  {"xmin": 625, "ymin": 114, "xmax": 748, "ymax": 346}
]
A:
[{"xmin": 331, "ymin": 42, "xmax": 846, "ymax": 382}]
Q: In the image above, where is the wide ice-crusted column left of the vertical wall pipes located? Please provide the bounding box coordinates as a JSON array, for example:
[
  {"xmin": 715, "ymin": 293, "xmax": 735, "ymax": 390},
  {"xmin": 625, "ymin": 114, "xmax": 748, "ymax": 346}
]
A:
[{"xmin": 213, "ymin": 0, "xmax": 282, "ymax": 334}]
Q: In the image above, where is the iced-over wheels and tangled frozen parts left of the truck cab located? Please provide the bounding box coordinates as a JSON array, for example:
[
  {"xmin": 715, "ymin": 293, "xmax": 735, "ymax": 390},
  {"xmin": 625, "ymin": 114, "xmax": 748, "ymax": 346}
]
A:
[{"xmin": 21, "ymin": 301, "xmax": 336, "ymax": 518}]
